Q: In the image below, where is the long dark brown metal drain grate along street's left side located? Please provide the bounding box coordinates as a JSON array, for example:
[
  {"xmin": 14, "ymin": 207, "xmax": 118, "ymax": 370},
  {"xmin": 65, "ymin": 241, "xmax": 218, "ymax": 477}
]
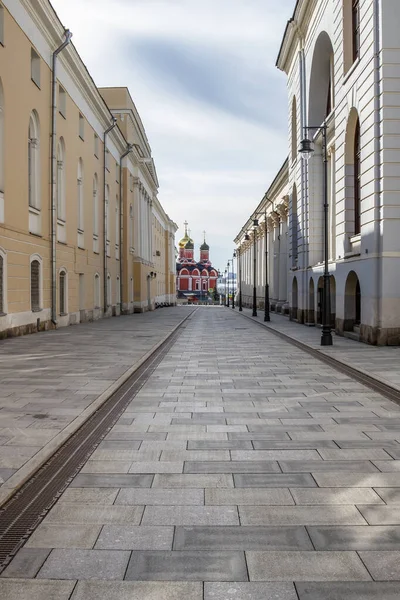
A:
[{"xmin": 0, "ymin": 311, "xmax": 195, "ymax": 573}]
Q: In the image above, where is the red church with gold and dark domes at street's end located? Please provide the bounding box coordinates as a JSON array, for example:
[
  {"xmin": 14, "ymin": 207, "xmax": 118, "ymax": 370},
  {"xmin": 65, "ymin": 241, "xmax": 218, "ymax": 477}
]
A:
[{"xmin": 176, "ymin": 221, "xmax": 218, "ymax": 302}]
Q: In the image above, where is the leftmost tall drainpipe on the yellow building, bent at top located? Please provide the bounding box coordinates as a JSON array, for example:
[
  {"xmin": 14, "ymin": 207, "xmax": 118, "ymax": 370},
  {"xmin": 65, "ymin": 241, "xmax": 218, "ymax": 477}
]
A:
[{"xmin": 50, "ymin": 29, "xmax": 72, "ymax": 325}]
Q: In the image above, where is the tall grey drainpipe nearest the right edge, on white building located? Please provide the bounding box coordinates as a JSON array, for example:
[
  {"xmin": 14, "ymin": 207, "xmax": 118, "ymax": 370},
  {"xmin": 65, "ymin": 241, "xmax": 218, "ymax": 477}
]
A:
[{"xmin": 374, "ymin": 0, "xmax": 383, "ymax": 338}]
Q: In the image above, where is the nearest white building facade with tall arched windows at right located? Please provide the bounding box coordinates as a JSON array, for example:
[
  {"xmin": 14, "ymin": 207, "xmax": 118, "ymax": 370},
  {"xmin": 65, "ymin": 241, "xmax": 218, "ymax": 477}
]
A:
[{"xmin": 234, "ymin": 0, "xmax": 400, "ymax": 345}]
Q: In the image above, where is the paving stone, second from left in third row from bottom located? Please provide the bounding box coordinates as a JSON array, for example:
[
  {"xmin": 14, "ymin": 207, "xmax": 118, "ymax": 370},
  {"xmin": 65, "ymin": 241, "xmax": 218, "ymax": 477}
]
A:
[{"xmin": 95, "ymin": 524, "xmax": 174, "ymax": 550}]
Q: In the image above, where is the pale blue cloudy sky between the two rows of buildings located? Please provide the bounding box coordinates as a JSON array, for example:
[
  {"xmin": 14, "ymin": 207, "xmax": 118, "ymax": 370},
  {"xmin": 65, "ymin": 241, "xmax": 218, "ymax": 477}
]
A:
[{"xmin": 52, "ymin": 0, "xmax": 295, "ymax": 270}]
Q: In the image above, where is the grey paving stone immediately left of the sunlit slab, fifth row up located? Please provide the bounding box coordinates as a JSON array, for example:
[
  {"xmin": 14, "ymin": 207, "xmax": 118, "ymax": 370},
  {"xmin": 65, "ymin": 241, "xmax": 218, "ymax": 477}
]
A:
[{"xmin": 205, "ymin": 488, "xmax": 294, "ymax": 506}]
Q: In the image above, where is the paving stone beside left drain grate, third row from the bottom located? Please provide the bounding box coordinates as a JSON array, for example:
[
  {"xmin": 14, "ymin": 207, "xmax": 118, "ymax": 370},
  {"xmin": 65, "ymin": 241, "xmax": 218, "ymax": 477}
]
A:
[{"xmin": 25, "ymin": 523, "xmax": 101, "ymax": 549}]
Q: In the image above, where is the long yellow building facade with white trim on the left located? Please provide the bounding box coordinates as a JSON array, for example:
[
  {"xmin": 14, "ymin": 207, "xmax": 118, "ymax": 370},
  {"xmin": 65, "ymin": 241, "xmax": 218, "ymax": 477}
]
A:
[{"xmin": 0, "ymin": 0, "xmax": 177, "ymax": 337}]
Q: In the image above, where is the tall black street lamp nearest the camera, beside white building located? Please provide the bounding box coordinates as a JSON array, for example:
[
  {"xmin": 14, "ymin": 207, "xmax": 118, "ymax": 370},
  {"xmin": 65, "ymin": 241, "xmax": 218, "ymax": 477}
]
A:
[{"xmin": 299, "ymin": 124, "xmax": 333, "ymax": 346}]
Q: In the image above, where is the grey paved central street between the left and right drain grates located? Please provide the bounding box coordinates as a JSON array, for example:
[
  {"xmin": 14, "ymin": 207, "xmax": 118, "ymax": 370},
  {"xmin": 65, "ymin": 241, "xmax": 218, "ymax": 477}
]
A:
[{"xmin": 0, "ymin": 307, "xmax": 400, "ymax": 600}]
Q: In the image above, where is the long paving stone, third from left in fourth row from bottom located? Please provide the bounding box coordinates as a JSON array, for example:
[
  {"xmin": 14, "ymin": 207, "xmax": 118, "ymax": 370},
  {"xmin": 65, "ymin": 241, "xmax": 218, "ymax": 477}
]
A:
[{"xmin": 239, "ymin": 505, "xmax": 366, "ymax": 525}]
